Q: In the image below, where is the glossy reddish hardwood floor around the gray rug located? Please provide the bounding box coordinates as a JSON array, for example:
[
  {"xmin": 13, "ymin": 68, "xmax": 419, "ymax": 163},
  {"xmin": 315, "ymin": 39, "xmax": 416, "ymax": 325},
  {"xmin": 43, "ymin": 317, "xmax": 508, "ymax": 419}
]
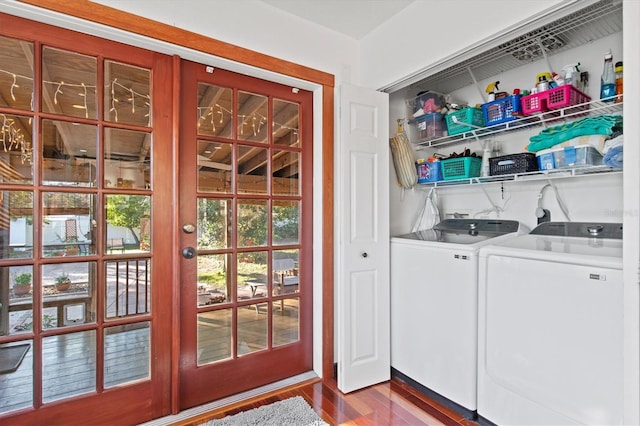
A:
[{"xmin": 173, "ymin": 378, "xmax": 477, "ymax": 426}]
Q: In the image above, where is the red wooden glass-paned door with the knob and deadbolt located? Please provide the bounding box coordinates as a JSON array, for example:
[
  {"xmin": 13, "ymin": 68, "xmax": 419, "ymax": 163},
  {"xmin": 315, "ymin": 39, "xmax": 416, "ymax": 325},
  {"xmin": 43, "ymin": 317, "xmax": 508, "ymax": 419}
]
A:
[{"xmin": 179, "ymin": 61, "xmax": 312, "ymax": 408}]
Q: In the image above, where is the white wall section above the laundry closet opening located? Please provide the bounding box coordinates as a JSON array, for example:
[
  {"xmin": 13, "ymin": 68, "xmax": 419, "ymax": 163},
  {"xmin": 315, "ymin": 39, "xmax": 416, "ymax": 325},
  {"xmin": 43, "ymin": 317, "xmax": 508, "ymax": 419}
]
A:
[{"xmin": 360, "ymin": 0, "xmax": 568, "ymax": 88}]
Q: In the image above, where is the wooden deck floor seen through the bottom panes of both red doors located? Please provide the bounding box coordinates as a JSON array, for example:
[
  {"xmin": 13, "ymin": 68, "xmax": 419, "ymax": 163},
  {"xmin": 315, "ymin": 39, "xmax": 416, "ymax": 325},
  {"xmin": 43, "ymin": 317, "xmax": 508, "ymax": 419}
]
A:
[{"xmin": 0, "ymin": 298, "xmax": 299, "ymax": 414}]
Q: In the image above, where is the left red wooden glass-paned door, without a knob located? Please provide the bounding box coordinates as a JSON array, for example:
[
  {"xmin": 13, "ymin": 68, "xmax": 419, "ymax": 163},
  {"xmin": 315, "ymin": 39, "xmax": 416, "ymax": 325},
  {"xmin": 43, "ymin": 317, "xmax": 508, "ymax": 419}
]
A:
[{"xmin": 0, "ymin": 14, "xmax": 174, "ymax": 425}]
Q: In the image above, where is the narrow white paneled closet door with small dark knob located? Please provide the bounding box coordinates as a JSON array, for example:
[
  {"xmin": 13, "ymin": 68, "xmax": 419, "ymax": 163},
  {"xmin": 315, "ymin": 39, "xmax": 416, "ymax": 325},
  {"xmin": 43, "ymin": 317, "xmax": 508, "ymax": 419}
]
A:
[{"xmin": 336, "ymin": 85, "xmax": 391, "ymax": 392}]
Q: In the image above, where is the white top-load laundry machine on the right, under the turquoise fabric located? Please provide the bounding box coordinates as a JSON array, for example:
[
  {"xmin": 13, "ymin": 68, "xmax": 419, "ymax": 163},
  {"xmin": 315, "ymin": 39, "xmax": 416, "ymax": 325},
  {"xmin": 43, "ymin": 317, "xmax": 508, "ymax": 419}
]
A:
[{"xmin": 478, "ymin": 222, "xmax": 623, "ymax": 425}]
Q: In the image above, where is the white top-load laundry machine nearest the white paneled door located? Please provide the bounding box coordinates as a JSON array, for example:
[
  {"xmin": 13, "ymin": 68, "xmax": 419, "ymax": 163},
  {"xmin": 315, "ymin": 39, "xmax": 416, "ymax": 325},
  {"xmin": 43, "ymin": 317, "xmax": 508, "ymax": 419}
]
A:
[{"xmin": 391, "ymin": 219, "xmax": 528, "ymax": 417}]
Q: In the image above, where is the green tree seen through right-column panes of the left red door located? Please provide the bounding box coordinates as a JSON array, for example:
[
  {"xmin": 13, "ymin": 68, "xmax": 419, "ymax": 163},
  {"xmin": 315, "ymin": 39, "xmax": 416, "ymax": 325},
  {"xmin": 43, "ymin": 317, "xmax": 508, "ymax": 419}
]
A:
[{"xmin": 107, "ymin": 195, "xmax": 151, "ymax": 244}]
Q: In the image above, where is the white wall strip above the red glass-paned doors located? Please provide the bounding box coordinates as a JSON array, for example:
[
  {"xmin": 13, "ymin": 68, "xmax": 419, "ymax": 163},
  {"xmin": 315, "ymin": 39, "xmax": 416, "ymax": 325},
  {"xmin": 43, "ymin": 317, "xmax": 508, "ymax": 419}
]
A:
[{"xmin": 94, "ymin": 0, "xmax": 360, "ymax": 85}]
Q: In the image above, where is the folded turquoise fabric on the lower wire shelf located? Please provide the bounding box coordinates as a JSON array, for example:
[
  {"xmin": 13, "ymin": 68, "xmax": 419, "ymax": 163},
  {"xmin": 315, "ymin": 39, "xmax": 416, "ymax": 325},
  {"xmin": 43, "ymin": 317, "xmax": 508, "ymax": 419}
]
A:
[{"xmin": 527, "ymin": 115, "xmax": 622, "ymax": 152}]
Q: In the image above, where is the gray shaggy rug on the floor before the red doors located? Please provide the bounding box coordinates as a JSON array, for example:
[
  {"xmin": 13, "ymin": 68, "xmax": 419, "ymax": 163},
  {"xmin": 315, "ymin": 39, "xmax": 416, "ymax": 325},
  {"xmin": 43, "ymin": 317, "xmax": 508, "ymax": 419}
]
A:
[{"xmin": 201, "ymin": 396, "xmax": 328, "ymax": 426}]
